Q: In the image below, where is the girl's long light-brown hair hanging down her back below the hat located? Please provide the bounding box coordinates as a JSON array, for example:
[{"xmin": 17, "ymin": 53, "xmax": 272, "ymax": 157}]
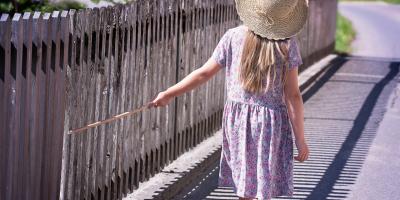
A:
[{"xmin": 239, "ymin": 30, "xmax": 289, "ymax": 94}]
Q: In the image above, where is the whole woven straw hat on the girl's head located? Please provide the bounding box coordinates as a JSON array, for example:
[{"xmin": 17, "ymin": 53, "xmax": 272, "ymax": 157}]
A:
[{"xmin": 235, "ymin": 0, "xmax": 308, "ymax": 40}]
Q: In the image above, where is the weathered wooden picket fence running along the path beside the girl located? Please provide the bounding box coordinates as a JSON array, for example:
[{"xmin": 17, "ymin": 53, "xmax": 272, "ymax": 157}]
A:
[{"xmin": 0, "ymin": 0, "xmax": 337, "ymax": 200}]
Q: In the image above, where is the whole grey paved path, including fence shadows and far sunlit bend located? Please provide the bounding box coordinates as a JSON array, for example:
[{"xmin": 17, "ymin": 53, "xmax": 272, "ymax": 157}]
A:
[{"xmin": 172, "ymin": 3, "xmax": 400, "ymax": 200}]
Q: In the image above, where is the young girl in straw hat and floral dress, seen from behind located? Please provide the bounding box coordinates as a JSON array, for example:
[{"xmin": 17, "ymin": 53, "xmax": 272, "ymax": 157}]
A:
[{"xmin": 150, "ymin": 0, "xmax": 309, "ymax": 199}]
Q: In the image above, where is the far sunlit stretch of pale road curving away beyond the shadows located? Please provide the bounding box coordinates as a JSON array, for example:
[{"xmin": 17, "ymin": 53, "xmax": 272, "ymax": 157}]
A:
[{"xmin": 339, "ymin": 2, "xmax": 400, "ymax": 58}]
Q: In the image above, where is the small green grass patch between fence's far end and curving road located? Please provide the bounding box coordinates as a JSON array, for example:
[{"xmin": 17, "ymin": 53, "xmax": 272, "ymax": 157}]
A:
[{"xmin": 335, "ymin": 13, "xmax": 356, "ymax": 53}]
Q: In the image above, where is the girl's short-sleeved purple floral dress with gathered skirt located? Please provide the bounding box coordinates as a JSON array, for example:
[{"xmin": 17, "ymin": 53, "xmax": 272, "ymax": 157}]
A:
[{"xmin": 212, "ymin": 25, "xmax": 302, "ymax": 199}]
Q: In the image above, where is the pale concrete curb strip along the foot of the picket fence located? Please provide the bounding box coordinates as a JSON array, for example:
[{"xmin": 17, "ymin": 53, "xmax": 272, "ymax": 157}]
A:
[{"xmin": 123, "ymin": 54, "xmax": 338, "ymax": 200}]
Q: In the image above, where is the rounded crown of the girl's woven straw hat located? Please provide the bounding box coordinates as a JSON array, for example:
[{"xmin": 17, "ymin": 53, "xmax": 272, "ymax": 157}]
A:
[{"xmin": 257, "ymin": 0, "xmax": 298, "ymax": 19}]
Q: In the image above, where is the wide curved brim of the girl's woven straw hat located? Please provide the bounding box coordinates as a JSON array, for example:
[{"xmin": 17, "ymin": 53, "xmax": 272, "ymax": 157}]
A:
[{"xmin": 235, "ymin": 0, "xmax": 308, "ymax": 40}]
